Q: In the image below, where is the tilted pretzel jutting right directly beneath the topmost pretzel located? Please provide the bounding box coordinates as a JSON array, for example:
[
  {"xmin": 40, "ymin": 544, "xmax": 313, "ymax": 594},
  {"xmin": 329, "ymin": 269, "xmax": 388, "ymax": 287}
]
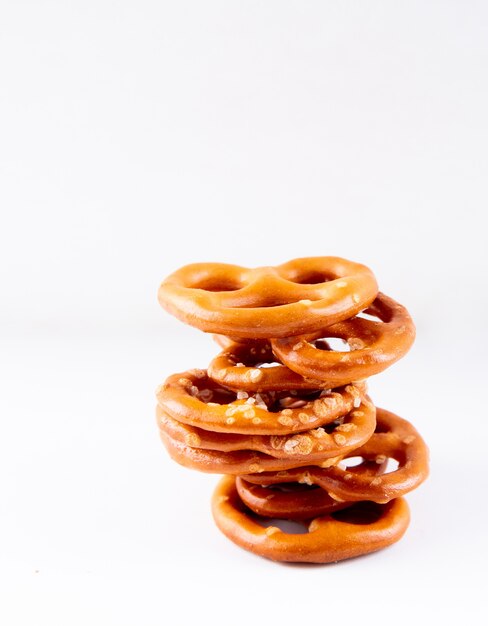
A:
[{"xmin": 271, "ymin": 293, "xmax": 415, "ymax": 387}]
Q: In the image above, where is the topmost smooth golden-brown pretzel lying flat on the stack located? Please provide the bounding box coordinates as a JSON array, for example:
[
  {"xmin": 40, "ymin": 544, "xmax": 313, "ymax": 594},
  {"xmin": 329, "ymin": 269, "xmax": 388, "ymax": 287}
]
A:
[{"xmin": 158, "ymin": 257, "xmax": 378, "ymax": 338}]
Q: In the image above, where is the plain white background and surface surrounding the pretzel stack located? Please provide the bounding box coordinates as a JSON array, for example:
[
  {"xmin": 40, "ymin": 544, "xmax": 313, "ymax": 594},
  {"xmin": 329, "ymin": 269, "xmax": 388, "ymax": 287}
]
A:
[{"xmin": 0, "ymin": 0, "xmax": 488, "ymax": 626}]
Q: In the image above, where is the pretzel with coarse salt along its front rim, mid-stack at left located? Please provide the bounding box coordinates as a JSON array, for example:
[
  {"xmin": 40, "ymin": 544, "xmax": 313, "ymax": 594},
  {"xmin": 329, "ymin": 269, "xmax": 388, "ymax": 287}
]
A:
[{"xmin": 156, "ymin": 368, "xmax": 365, "ymax": 435}]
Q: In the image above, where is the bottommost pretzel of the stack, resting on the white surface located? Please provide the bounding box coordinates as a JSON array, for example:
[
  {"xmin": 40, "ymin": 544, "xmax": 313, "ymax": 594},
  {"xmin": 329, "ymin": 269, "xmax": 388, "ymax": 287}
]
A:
[{"xmin": 212, "ymin": 476, "xmax": 410, "ymax": 563}]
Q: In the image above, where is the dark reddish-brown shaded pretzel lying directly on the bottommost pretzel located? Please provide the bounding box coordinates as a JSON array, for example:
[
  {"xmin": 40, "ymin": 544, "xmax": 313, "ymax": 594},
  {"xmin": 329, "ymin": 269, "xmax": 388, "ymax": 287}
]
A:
[{"xmin": 236, "ymin": 477, "xmax": 349, "ymax": 520}]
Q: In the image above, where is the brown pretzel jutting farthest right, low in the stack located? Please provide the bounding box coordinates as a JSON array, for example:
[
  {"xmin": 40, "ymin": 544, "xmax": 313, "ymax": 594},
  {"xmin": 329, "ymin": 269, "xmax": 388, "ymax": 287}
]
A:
[{"xmin": 243, "ymin": 408, "xmax": 429, "ymax": 503}]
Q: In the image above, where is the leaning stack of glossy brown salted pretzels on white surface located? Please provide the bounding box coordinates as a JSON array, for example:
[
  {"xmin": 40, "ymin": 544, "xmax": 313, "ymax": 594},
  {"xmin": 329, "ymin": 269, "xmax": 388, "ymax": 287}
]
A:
[{"xmin": 157, "ymin": 257, "xmax": 428, "ymax": 563}]
